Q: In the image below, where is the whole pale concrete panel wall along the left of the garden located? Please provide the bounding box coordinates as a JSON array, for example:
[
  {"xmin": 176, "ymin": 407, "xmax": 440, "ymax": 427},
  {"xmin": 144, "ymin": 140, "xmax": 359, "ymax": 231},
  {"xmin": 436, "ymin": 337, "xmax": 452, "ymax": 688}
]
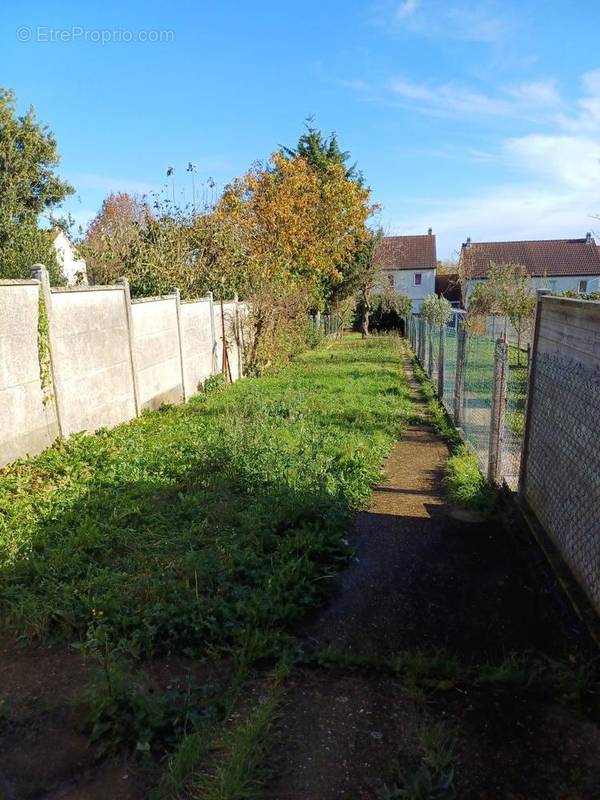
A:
[{"xmin": 0, "ymin": 269, "xmax": 247, "ymax": 466}]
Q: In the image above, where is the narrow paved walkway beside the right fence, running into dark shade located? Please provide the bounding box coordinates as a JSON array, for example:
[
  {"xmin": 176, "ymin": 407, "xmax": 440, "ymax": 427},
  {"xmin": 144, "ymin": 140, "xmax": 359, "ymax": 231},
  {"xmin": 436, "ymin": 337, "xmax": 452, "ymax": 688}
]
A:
[{"xmin": 265, "ymin": 344, "xmax": 600, "ymax": 800}]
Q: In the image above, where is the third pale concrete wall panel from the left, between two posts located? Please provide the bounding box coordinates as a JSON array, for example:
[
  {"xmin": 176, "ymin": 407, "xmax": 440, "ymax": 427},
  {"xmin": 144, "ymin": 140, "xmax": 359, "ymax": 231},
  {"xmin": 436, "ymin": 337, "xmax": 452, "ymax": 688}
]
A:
[{"xmin": 131, "ymin": 295, "xmax": 183, "ymax": 409}]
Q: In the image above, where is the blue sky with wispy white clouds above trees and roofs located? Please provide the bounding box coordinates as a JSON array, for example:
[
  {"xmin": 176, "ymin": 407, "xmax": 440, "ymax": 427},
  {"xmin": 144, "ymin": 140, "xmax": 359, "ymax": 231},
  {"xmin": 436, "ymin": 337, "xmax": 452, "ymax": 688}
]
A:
[{"xmin": 0, "ymin": 0, "xmax": 600, "ymax": 257}]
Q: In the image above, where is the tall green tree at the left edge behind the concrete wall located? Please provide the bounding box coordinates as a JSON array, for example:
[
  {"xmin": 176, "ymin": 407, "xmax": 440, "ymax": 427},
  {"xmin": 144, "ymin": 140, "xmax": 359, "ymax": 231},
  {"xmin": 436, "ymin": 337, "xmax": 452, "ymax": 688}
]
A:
[{"xmin": 0, "ymin": 88, "xmax": 74, "ymax": 282}]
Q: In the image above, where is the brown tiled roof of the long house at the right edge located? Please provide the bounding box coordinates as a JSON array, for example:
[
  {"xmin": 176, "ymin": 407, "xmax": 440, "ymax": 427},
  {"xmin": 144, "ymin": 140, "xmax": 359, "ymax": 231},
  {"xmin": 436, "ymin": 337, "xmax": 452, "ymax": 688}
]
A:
[{"xmin": 460, "ymin": 239, "xmax": 600, "ymax": 278}]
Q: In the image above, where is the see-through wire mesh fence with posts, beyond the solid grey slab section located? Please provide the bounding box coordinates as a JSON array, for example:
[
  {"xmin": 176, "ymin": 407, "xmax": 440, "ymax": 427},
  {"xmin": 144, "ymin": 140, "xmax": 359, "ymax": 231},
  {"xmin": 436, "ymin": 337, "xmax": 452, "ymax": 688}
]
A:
[{"xmin": 406, "ymin": 315, "xmax": 528, "ymax": 490}]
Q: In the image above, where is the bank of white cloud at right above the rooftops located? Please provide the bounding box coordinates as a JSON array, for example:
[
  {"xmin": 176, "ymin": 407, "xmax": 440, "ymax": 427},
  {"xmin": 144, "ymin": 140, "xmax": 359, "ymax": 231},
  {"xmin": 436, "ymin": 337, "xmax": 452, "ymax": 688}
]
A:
[{"xmin": 382, "ymin": 70, "xmax": 600, "ymax": 258}]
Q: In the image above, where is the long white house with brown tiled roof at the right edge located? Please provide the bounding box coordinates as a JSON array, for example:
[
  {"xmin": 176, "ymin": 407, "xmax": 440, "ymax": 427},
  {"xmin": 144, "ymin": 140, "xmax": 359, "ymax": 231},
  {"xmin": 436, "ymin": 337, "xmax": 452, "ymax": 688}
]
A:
[{"xmin": 460, "ymin": 238, "xmax": 600, "ymax": 304}]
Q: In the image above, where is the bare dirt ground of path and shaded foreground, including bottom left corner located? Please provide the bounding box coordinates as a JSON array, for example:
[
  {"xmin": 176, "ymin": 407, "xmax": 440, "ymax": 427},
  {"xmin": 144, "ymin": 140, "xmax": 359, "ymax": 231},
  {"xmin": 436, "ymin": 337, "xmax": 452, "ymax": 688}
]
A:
[{"xmin": 0, "ymin": 346, "xmax": 600, "ymax": 800}]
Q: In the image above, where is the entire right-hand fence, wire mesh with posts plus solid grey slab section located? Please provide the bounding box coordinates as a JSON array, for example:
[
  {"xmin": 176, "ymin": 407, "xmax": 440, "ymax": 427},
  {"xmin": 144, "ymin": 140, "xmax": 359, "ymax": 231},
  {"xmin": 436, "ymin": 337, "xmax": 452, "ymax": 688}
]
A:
[{"xmin": 406, "ymin": 296, "xmax": 600, "ymax": 610}]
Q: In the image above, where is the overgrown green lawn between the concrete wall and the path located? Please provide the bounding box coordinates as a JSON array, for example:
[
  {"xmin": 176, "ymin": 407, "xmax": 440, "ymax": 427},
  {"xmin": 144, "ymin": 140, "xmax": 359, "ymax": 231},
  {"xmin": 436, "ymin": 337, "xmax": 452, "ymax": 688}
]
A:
[{"xmin": 0, "ymin": 337, "xmax": 410, "ymax": 656}]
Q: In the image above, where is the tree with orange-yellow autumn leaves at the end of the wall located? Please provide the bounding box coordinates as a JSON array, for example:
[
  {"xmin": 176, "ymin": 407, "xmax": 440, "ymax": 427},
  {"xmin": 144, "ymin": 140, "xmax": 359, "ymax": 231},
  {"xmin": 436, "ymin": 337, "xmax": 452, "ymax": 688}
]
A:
[{"xmin": 216, "ymin": 152, "xmax": 372, "ymax": 371}]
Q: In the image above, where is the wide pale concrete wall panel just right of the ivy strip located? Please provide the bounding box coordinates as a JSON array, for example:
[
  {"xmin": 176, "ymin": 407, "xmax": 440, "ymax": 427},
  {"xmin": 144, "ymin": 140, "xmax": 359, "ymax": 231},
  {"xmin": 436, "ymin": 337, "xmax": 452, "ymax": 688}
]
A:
[{"xmin": 50, "ymin": 286, "xmax": 136, "ymax": 436}]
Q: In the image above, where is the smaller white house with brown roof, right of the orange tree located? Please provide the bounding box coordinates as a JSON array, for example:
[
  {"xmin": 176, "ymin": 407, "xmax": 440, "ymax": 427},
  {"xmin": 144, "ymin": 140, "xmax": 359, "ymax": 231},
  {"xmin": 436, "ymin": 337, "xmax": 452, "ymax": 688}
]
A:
[{"xmin": 374, "ymin": 228, "xmax": 437, "ymax": 312}]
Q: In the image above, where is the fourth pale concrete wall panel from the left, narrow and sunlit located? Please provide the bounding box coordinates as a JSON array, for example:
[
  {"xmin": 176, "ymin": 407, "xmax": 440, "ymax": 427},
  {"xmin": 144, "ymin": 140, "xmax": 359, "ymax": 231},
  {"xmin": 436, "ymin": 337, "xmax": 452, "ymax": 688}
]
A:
[{"xmin": 179, "ymin": 297, "xmax": 216, "ymax": 397}]
